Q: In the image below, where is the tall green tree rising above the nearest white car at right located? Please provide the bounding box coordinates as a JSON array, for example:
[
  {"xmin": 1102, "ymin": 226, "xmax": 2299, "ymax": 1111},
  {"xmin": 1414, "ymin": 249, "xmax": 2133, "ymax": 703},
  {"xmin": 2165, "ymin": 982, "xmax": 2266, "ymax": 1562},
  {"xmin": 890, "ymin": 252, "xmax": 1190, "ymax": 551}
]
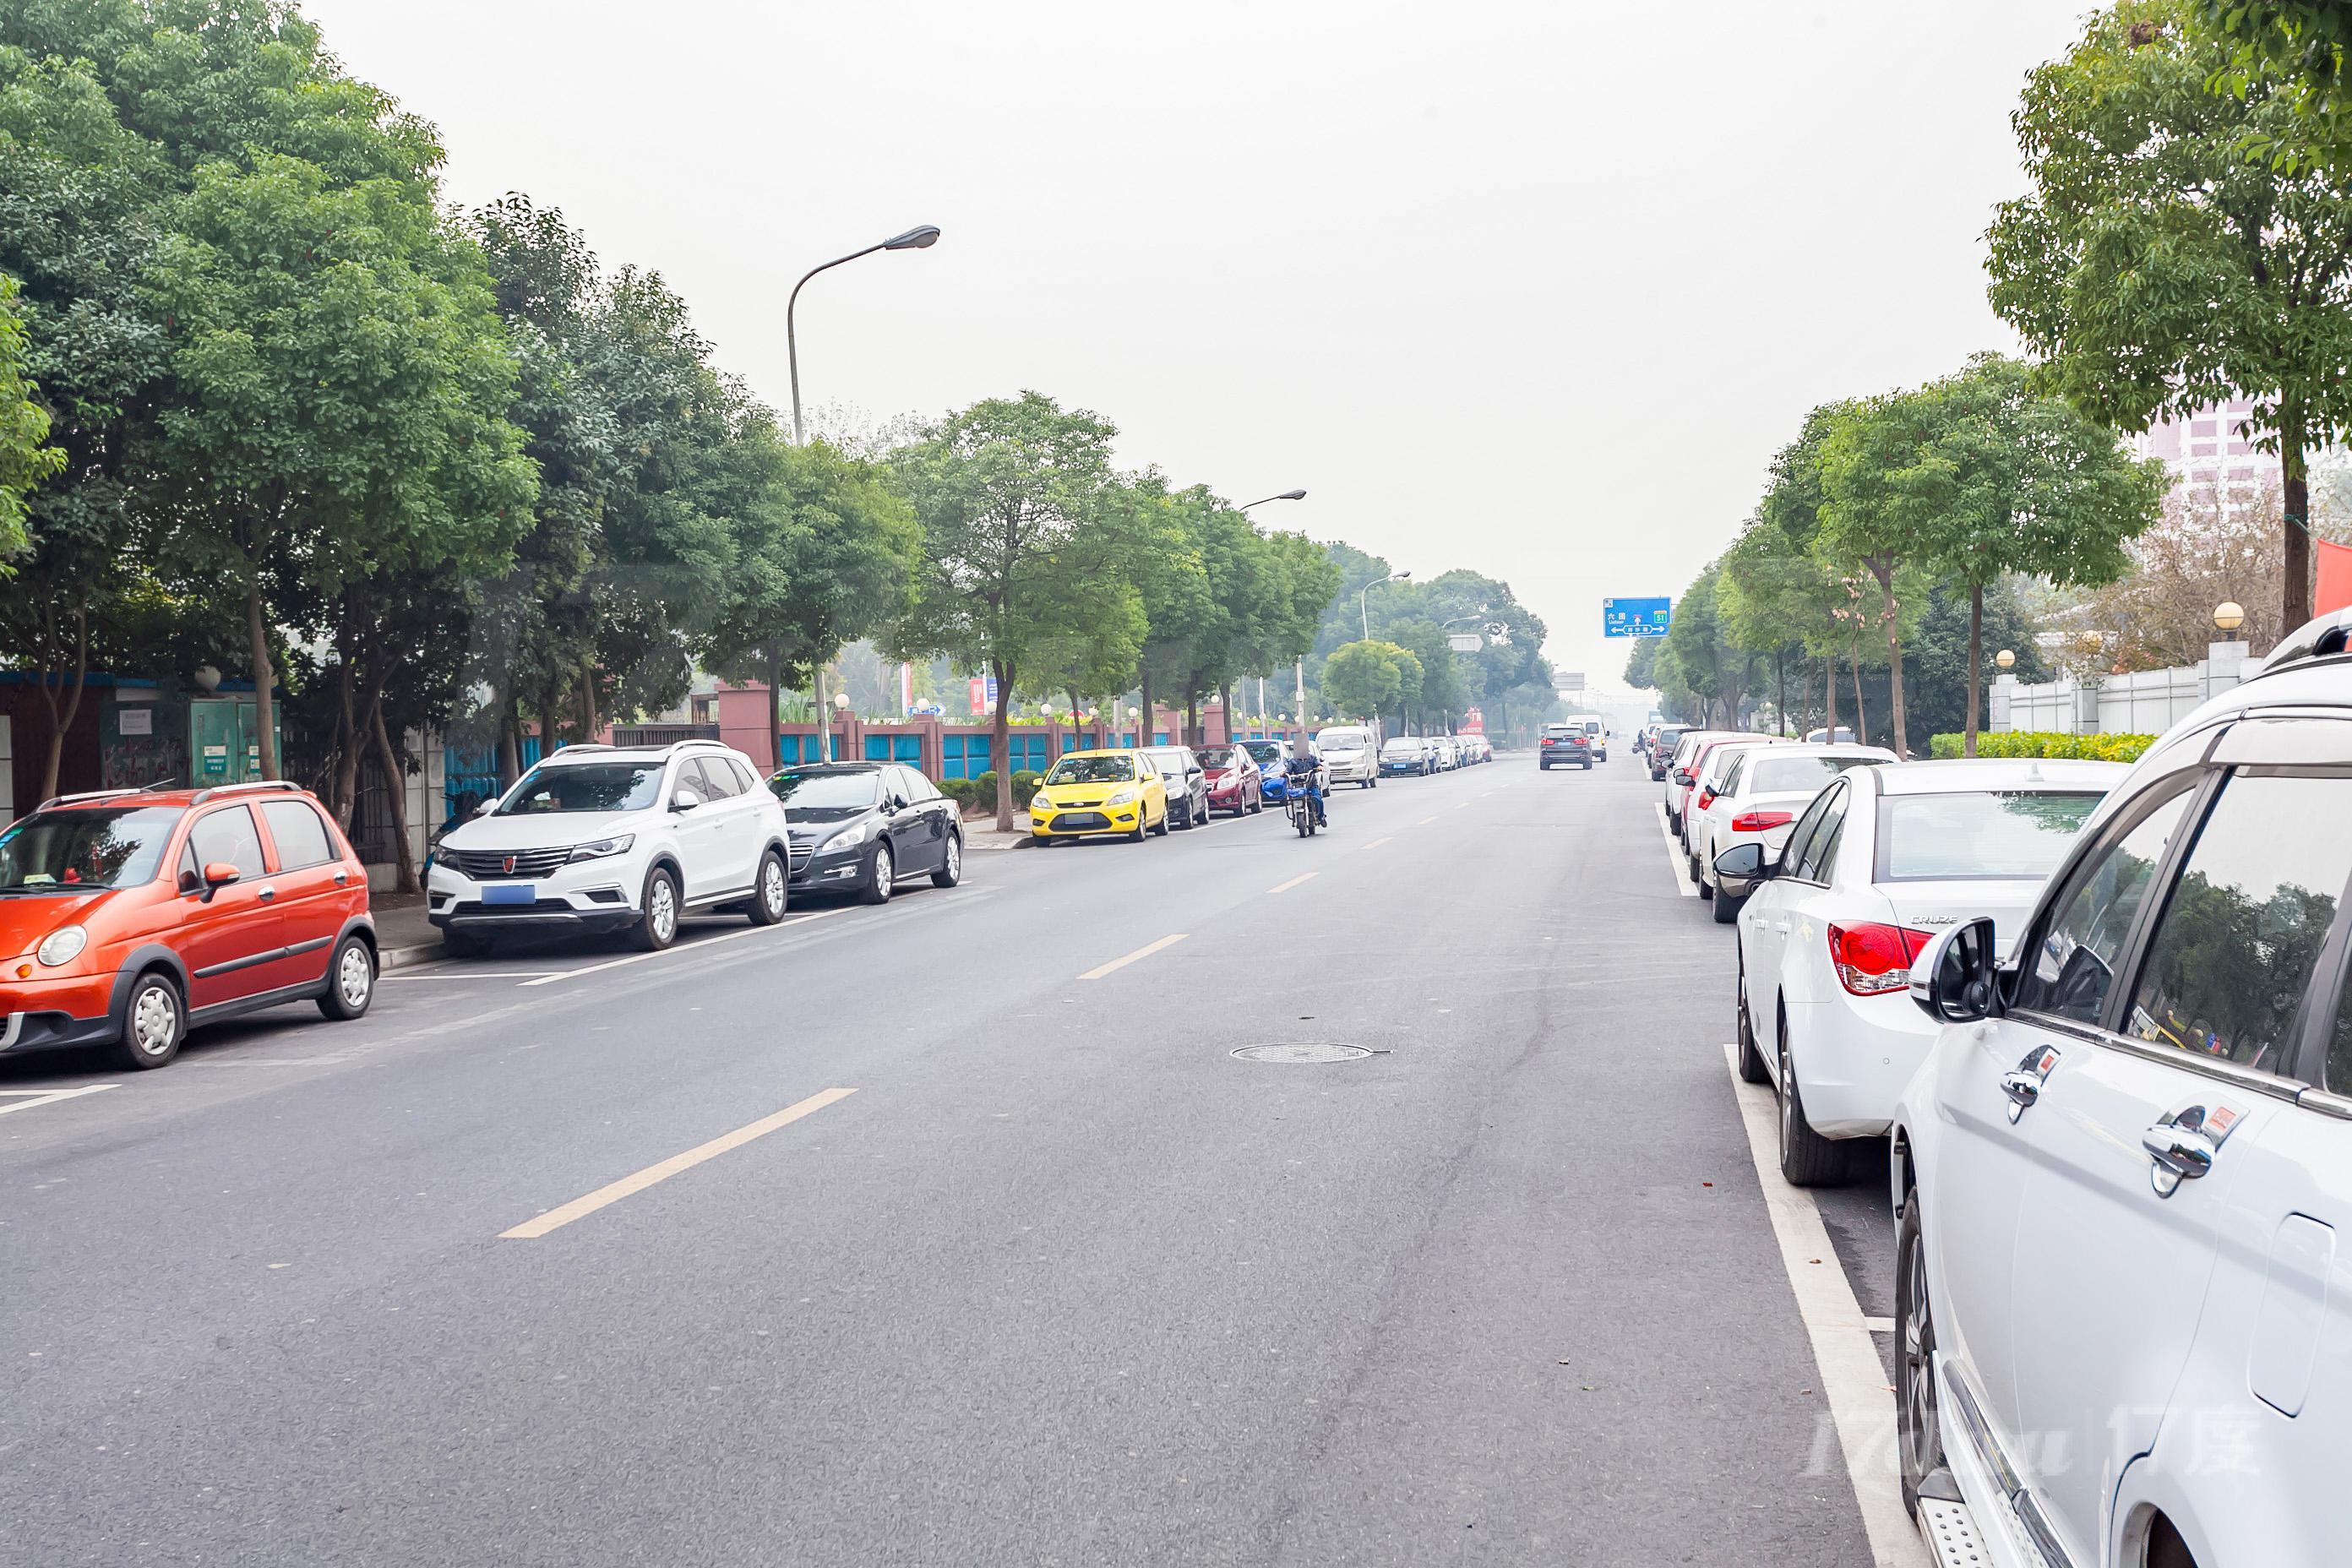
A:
[{"xmin": 1987, "ymin": 0, "xmax": 2352, "ymax": 630}]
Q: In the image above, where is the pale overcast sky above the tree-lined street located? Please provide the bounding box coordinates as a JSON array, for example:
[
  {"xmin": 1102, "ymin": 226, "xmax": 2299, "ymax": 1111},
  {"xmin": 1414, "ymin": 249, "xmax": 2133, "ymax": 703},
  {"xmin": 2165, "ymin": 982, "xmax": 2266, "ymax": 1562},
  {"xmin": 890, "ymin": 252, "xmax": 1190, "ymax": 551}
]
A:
[{"xmin": 306, "ymin": 0, "xmax": 2086, "ymax": 687}]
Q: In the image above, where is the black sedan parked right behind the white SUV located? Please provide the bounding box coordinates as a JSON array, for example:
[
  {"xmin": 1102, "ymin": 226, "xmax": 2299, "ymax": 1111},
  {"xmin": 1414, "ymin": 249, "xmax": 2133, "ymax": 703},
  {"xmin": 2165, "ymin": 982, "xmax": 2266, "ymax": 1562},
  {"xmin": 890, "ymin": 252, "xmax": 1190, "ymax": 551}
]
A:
[{"xmin": 767, "ymin": 762, "xmax": 964, "ymax": 903}]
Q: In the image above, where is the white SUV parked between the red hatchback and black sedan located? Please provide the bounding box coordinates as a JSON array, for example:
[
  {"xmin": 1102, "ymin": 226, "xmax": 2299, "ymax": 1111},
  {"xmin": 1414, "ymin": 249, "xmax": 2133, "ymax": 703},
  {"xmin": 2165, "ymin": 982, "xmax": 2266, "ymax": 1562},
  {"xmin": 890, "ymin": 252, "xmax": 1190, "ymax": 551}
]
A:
[{"xmin": 426, "ymin": 741, "xmax": 790, "ymax": 955}]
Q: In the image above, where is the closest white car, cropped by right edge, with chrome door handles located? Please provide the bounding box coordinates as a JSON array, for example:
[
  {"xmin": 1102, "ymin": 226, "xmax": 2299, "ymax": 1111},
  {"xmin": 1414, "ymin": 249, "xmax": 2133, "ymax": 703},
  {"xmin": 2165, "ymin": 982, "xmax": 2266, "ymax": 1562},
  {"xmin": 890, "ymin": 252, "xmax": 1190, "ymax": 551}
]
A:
[{"xmin": 1889, "ymin": 611, "xmax": 2352, "ymax": 1568}]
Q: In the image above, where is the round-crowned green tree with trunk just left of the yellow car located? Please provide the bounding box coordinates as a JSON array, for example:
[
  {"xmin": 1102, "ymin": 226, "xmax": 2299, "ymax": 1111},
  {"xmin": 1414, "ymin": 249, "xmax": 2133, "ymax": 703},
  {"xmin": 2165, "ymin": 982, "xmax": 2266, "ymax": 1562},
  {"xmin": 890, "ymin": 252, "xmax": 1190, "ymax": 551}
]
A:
[{"xmin": 891, "ymin": 393, "xmax": 1148, "ymax": 832}]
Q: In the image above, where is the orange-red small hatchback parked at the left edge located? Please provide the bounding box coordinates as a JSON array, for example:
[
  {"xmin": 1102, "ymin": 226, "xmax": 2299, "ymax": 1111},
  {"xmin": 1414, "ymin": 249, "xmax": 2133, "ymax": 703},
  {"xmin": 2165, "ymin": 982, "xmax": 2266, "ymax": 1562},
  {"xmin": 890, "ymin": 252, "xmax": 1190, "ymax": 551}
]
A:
[{"xmin": 0, "ymin": 783, "xmax": 376, "ymax": 1067}]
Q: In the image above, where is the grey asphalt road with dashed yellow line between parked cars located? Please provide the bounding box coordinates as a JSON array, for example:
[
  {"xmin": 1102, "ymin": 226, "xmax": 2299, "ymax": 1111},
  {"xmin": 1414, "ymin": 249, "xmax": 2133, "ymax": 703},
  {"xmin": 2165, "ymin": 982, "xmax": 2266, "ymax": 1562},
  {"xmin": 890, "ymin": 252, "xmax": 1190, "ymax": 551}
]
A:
[{"xmin": 0, "ymin": 754, "xmax": 1881, "ymax": 1568}]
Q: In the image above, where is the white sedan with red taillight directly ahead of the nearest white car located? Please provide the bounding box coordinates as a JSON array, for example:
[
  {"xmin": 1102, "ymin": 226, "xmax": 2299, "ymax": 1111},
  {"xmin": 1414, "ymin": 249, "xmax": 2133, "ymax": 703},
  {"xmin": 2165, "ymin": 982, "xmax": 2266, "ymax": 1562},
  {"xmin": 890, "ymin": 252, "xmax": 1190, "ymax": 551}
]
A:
[{"xmin": 1715, "ymin": 748, "xmax": 2124, "ymax": 1187}]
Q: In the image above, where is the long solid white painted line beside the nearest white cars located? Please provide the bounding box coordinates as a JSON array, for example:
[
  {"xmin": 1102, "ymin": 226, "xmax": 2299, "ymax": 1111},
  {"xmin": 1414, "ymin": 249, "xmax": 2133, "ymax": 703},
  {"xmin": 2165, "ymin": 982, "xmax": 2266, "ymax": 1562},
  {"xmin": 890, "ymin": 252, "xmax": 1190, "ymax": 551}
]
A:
[{"xmin": 1724, "ymin": 1046, "xmax": 1929, "ymax": 1568}]
